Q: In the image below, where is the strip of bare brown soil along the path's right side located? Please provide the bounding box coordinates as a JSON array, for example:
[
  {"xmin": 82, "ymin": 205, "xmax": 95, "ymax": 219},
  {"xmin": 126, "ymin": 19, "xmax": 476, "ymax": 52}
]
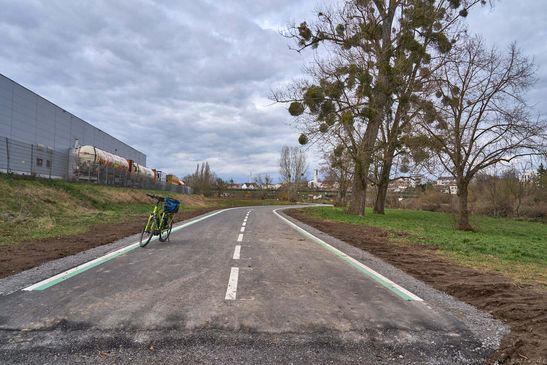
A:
[{"xmin": 285, "ymin": 209, "xmax": 547, "ymax": 364}]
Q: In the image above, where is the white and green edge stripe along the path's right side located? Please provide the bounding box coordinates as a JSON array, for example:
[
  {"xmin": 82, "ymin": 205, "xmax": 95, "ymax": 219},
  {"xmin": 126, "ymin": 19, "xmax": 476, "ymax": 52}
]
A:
[{"xmin": 273, "ymin": 208, "xmax": 423, "ymax": 302}]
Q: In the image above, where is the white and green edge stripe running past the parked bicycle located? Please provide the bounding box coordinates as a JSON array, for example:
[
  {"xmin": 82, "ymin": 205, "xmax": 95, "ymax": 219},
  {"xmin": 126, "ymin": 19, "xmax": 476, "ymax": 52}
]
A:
[{"xmin": 23, "ymin": 207, "xmax": 233, "ymax": 291}]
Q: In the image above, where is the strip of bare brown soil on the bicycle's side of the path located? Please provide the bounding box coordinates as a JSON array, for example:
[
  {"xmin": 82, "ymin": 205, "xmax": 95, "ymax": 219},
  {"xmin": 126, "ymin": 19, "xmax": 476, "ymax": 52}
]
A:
[{"xmin": 0, "ymin": 208, "xmax": 216, "ymax": 278}]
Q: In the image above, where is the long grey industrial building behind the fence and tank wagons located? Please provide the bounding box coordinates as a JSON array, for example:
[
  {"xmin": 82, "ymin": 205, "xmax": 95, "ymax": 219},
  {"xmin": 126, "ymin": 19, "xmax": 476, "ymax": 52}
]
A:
[{"xmin": 0, "ymin": 74, "xmax": 146, "ymax": 178}]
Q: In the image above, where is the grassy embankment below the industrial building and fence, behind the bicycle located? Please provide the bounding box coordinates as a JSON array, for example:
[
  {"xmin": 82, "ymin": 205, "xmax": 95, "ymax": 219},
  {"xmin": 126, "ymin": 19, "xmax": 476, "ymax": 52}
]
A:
[{"xmin": 0, "ymin": 174, "xmax": 296, "ymax": 245}]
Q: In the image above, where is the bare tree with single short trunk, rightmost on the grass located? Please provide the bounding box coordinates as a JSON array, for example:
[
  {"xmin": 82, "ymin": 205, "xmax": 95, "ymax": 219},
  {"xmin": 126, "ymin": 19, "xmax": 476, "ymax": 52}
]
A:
[{"xmin": 421, "ymin": 38, "xmax": 545, "ymax": 230}]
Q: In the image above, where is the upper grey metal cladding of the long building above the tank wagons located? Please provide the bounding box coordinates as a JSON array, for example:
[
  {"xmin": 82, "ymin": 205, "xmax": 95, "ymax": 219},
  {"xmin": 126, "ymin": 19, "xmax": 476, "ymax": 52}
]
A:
[{"xmin": 0, "ymin": 74, "xmax": 146, "ymax": 166}]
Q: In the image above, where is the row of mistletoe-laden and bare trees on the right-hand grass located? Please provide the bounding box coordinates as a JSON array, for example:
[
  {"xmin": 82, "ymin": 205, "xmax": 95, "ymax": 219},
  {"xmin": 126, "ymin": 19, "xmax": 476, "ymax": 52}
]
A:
[{"xmin": 274, "ymin": 0, "xmax": 545, "ymax": 230}]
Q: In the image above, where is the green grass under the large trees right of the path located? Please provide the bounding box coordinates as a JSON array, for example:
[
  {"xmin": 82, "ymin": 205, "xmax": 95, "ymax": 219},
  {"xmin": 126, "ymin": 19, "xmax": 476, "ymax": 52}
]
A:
[{"xmin": 305, "ymin": 207, "xmax": 547, "ymax": 286}]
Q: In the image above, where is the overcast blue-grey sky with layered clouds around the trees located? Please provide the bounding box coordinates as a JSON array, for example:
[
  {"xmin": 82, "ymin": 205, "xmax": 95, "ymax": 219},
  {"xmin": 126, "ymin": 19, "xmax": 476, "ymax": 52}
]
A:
[{"xmin": 0, "ymin": 0, "xmax": 547, "ymax": 182}]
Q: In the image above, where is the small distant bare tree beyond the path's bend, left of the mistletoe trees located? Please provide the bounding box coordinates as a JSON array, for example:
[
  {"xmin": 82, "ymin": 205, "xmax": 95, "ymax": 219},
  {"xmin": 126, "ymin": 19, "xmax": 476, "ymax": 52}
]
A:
[{"xmin": 279, "ymin": 146, "xmax": 308, "ymax": 199}]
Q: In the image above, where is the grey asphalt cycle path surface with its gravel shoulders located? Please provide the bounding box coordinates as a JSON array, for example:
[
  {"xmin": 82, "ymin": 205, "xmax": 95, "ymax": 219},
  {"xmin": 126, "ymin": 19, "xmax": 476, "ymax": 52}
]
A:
[{"xmin": 0, "ymin": 207, "xmax": 504, "ymax": 364}]
